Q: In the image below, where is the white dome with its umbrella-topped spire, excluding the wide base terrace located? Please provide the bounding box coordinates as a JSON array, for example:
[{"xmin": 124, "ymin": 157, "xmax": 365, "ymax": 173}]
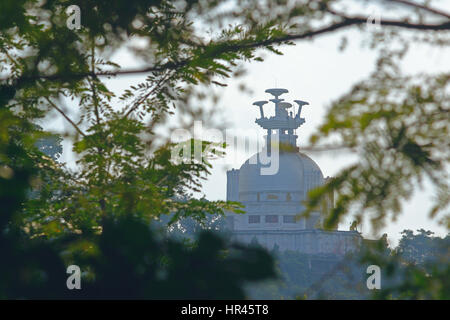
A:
[{"xmin": 227, "ymin": 88, "xmax": 330, "ymax": 234}]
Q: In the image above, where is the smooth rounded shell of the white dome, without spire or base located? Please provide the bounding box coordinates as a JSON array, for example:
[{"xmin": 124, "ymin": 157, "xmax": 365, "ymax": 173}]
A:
[{"xmin": 239, "ymin": 152, "xmax": 323, "ymax": 194}]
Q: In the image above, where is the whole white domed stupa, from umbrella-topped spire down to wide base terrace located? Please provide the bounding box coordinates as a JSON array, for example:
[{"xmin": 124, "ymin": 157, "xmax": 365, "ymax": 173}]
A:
[{"xmin": 227, "ymin": 89, "xmax": 362, "ymax": 255}]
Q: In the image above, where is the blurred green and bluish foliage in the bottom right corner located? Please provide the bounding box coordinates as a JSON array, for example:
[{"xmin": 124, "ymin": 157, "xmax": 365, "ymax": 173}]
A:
[{"xmin": 361, "ymin": 229, "xmax": 450, "ymax": 300}]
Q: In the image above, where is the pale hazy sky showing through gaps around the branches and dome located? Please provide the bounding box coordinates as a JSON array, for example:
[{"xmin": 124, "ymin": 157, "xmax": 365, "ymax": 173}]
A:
[{"xmin": 49, "ymin": 5, "xmax": 450, "ymax": 244}]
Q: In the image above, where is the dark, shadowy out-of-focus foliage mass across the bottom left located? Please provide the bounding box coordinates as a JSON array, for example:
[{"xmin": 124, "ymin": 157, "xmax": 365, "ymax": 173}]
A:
[{"xmin": 0, "ymin": 117, "xmax": 274, "ymax": 299}]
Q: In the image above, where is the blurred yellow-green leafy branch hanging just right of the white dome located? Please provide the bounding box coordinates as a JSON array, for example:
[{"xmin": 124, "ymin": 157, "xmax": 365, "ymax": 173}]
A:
[{"xmin": 309, "ymin": 54, "xmax": 450, "ymax": 231}]
